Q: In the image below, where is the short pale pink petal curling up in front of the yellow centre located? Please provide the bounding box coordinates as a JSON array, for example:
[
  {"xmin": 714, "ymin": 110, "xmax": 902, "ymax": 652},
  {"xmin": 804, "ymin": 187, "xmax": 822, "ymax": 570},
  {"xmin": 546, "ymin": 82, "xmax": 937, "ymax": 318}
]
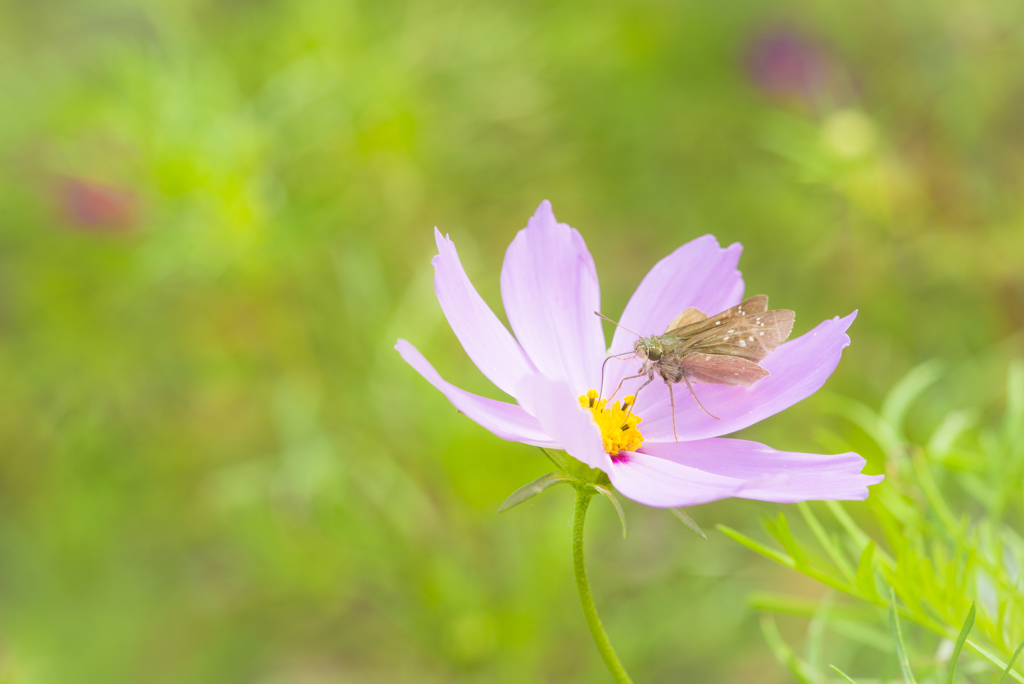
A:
[{"xmin": 516, "ymin": 374, "xmax": 611, "ymax": 472}]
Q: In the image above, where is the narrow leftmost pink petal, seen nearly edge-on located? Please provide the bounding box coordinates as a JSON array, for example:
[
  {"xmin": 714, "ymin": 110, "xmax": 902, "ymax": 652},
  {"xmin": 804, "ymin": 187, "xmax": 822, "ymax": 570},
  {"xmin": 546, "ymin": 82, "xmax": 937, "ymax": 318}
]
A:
[{"xmin": 394, "ymin": 340, "xmax": 561, "ymax": 448}]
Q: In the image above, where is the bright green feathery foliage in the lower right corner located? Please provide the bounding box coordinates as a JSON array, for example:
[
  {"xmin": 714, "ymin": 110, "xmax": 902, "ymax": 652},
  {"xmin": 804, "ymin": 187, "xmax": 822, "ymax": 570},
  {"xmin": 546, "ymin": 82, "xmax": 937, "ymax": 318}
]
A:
[{"xmin": 720, "ymin": 362, "xmax": 1024, "ymax": 684}]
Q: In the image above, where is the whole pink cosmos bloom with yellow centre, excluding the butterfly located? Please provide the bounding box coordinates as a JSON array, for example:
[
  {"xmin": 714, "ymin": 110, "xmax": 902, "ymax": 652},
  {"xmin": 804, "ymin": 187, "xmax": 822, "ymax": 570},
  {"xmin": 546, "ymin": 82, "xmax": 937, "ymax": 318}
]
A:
[{"xmin": 395, "ymin": 201, "xmax": 883, "ymax": 508}]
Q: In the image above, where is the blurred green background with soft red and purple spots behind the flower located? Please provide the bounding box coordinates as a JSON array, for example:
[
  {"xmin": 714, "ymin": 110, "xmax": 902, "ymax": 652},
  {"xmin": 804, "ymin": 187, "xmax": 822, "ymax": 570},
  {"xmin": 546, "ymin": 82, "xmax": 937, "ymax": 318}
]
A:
[{"xmin": 0, "ymin": 0, "xmax": 1024, "ymax": 684}]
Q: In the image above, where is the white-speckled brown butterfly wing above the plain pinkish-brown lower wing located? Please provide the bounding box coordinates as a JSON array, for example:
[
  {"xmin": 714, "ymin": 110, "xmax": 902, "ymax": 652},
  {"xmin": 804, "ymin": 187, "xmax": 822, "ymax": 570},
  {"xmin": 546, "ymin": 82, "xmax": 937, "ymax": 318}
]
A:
[{"xmin": 679, "ymin": 309, "xmax": 796, "ymax": 362}]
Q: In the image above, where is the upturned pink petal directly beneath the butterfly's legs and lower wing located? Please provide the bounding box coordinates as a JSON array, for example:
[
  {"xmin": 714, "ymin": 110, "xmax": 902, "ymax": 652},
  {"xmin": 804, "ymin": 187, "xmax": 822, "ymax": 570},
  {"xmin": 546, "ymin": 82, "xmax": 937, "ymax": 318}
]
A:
[{"xmin": 634, "ymin": 311, "xmax": 857, "ymax": 444}]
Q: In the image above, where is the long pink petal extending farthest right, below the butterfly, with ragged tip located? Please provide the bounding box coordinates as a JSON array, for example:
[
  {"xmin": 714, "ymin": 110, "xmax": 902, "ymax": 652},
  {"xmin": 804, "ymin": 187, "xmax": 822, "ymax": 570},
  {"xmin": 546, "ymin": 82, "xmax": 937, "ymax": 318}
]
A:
[{"xmin": 638, "ymin": 439, "xmax": 885, "ymax": 504}]
